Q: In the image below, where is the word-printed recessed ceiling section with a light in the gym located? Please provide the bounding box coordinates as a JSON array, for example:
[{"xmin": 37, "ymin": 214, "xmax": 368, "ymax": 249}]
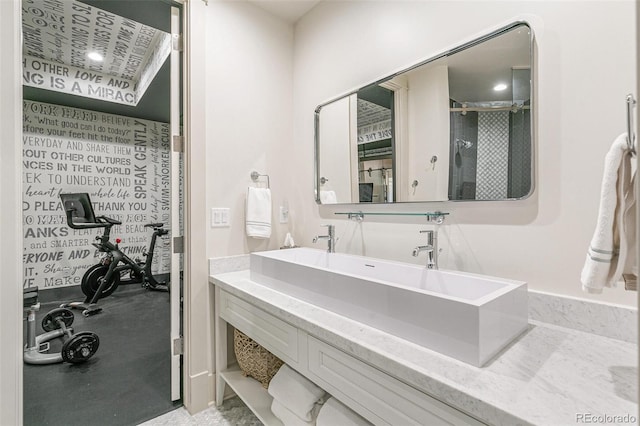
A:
[{"xmin": 22, "ymin": 0, "xmax": 171, "ymax": 106}]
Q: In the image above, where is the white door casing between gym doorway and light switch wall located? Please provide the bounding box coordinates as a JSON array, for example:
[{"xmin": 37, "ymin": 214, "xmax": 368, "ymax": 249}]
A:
[{"xmin": 182, "ymin": 0, "xmax": 215, "ymax": 414}]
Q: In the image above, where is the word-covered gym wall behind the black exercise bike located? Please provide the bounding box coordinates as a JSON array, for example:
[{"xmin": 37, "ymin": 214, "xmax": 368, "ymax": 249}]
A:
[{"xmin": 22, "ymin": 101, "xmax": 171, "ymax": 289}]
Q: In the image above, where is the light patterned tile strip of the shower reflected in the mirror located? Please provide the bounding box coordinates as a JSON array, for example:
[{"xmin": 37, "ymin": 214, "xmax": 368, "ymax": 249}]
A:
[{"xmin": 476, "ymin": 111, "xmax": 510, "ymax": 200}]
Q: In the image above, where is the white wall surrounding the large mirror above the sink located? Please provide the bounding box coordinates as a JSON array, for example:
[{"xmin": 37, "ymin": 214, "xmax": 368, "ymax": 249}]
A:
[{"xmin": 290, "ymin": 0, "xmax": 636, "ymax": 305}]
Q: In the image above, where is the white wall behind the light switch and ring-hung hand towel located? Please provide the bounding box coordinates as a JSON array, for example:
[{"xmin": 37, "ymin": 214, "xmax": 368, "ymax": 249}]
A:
[{"xmin": 203, "ymin": 1, "xmax": 296, "ymax": 257}]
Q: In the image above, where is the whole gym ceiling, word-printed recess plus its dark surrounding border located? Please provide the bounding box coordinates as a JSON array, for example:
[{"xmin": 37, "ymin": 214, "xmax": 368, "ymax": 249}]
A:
[{"xmin": 23, "ymin": 0, "xmax": 171, "ymax": 122}]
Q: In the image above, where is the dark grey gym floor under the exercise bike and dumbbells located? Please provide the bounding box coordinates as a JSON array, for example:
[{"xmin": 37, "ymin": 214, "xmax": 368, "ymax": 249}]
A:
[{"xmin": 24, "ymin": 285, "xmax": 181, "ymax": 426}]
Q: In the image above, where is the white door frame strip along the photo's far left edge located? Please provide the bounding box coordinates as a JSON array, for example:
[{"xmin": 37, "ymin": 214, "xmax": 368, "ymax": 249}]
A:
[{"xmin": 0, "ymin": 0, "xmax": 23, "ymax": 425}]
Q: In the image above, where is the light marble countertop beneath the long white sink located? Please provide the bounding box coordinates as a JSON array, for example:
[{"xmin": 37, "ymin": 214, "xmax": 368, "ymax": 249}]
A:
[{"xmin": 210, "ymin": 271, "xmax": 638, "ymax": 426}]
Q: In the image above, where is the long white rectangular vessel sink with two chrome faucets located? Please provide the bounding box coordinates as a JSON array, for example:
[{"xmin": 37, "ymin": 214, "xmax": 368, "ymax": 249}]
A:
[{"xmin": 250, "ymin": 248, "xmax": 527, "ymax": 367}]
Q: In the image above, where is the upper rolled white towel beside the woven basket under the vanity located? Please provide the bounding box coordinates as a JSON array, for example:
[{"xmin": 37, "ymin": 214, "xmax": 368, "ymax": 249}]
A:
[{"xmin": 268, "ymin": 364, "xmax": 328, "ymax": 422}]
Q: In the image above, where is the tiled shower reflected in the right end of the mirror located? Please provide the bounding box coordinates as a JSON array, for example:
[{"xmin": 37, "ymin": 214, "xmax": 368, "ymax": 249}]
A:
[{"xmin": 449, "ymin": 66, "xmax": 531, "ymax": 200}]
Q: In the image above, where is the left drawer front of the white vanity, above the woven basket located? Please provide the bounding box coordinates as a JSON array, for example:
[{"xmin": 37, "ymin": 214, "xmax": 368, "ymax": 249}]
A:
[{"xmin": 219, "ymin": 291, "xmax": 298, "ymax": 365}]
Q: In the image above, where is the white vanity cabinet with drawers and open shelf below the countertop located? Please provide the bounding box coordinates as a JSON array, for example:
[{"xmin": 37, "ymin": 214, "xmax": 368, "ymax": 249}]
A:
[{"xmin": 215, "ymin": 286, "xmax": 482, "ymax": 425}]
